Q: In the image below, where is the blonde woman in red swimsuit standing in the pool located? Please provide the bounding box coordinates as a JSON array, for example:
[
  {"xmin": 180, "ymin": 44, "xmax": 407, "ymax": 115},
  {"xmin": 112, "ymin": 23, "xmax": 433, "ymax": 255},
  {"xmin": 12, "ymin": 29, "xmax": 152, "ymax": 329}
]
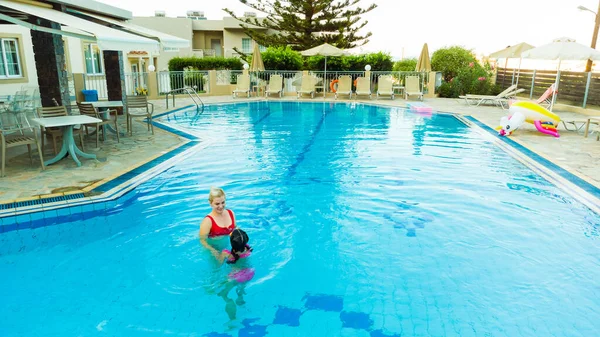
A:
[{"xmin": 199, "ymin": 187, "xmax": 235, "ymax": 259}]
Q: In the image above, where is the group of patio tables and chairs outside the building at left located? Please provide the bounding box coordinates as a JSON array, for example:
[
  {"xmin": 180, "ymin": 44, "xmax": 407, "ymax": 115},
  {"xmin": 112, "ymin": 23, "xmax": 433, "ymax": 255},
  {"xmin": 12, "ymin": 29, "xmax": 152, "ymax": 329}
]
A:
[{"xmin": 0, "ymin": 89, "xmax": 154, "ymax": 177}]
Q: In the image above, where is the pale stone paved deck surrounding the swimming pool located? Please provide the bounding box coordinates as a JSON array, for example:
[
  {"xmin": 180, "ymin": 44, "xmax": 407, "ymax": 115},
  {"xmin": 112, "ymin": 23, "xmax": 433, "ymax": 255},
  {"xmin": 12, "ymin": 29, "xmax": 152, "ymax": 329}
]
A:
[{"xmin": 0, "ymin": 96, "xmax": 600, "ymax": 209}]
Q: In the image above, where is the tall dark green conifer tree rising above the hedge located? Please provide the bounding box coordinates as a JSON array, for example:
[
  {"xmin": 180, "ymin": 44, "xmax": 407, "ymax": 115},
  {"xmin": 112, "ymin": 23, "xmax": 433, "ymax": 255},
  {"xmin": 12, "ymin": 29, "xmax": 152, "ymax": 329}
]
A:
[{"xmin": 223, "ymin": 0, "xmax": 377, "ymax": 50}]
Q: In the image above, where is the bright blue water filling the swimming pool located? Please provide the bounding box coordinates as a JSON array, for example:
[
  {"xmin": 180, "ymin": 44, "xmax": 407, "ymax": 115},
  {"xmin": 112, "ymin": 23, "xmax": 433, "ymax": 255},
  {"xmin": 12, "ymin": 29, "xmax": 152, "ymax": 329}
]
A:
[{"xmin": 0, "ymin": 102, "xmax": 600, "ymax": 337}]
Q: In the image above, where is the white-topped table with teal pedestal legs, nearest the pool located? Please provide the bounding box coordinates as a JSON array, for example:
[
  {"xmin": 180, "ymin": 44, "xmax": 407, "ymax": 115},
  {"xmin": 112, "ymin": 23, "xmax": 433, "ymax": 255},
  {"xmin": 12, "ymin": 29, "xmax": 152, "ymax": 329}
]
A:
[{"xmin": 31, "ymin": 115, "xmax": 102, "ymax": 166}]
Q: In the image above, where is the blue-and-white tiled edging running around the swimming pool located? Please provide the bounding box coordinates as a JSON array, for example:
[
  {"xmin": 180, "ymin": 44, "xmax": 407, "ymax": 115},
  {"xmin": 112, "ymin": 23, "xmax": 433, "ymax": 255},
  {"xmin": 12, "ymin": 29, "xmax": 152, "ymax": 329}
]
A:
[{"xmin": 0, "ymin": 99, "xmax": 600, "ymax": 226}]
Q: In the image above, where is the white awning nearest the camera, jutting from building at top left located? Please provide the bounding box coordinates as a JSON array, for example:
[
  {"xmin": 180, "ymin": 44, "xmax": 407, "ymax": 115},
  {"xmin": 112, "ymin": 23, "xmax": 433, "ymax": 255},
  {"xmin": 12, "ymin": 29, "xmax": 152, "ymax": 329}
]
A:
[{"xmin": 0, "ymin": 0, "xmax": 159, "ymax": 54}]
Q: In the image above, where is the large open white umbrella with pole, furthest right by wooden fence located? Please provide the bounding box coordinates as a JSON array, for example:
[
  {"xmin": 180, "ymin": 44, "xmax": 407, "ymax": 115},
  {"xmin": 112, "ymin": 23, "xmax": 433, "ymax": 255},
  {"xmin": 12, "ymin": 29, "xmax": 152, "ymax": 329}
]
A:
[{"xmin": 521, "ymin": 37, "xmax": 600, "ymax": 111}]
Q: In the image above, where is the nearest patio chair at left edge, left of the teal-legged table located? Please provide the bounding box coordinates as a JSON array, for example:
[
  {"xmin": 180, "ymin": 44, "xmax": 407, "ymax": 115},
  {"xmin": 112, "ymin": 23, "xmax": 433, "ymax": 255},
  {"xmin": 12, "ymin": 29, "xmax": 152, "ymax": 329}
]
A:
[{"xmin": 0, "ymin": 112, "xmax": 45, "ymax": 177}]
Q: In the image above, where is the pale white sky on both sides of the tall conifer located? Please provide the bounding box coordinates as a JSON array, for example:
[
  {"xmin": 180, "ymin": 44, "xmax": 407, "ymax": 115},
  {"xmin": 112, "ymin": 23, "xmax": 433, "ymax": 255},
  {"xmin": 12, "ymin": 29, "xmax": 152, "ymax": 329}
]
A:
[{"xmin": 98, "ymin": 0, "xmax": 600, "ymax": 67}]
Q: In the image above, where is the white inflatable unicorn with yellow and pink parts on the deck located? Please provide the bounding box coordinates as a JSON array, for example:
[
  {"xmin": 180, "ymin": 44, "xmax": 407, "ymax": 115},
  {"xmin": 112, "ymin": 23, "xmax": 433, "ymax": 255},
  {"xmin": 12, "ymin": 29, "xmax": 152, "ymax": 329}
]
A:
[{"xmin": 496, "ymin": 101, "xmax": 560, "ymax": 137}]
